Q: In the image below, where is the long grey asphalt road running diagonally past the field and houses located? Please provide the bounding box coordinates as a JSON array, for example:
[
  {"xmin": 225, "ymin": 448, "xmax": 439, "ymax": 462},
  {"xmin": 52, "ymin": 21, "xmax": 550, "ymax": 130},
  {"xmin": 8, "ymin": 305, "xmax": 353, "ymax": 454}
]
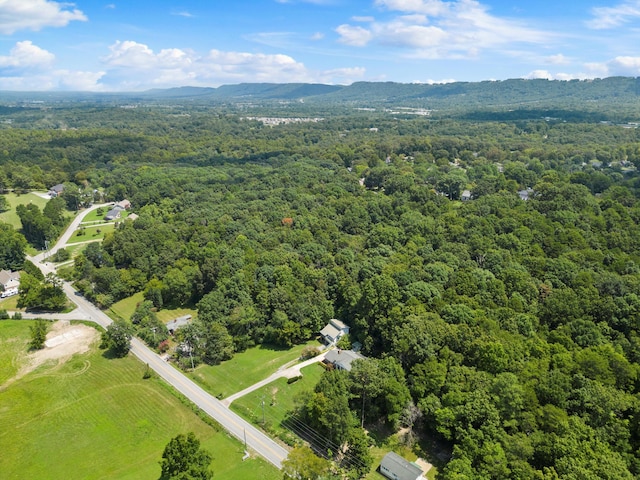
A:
[{"xmin": 28, "ymin": 205, "xmax": 289, "ymax": 468}]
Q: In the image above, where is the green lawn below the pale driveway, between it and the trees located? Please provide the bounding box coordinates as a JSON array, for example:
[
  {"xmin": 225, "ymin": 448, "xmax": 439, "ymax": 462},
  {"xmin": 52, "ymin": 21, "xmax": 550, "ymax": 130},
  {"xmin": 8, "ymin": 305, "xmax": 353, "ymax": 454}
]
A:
[{"xmin": 231, "ymin": 364, "xmax": 324, "ymax": 435}]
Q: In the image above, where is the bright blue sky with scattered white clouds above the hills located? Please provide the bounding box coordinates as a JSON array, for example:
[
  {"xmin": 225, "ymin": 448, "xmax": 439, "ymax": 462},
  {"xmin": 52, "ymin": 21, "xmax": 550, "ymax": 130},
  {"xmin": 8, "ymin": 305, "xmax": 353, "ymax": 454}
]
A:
[{"xmin": 0, "ymin": 0, "xmax": 640, "ymax": 91}]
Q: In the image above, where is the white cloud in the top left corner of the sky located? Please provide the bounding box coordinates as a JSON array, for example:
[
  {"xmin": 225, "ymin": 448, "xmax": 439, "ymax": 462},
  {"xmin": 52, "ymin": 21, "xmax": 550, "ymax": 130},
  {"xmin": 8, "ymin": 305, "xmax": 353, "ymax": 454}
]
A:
[{"xmin": 0, "ymin": 0, "xmax": 87, "ymax": 35}]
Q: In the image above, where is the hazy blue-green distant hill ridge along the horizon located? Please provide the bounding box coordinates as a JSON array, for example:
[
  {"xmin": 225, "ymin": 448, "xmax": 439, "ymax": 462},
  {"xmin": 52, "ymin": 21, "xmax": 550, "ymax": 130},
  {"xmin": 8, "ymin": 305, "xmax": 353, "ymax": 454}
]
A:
[{"xmin": 0, "ymin": 77, "xmax": 640, "ymax": 121}]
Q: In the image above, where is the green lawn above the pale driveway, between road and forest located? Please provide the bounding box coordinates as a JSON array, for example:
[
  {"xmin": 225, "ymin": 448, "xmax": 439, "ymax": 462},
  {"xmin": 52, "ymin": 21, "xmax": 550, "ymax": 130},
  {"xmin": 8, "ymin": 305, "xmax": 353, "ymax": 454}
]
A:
[{"xmin": 189, "ymin": 340, "xmax": 318, "ymax": 398}]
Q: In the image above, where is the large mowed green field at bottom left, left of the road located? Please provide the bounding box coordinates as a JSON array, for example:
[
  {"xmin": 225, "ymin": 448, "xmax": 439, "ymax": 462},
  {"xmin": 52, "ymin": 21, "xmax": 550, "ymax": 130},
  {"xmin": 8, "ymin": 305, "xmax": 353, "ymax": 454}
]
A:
[{"xmin": 0, "ymin": 321, "xmax": 281, "ymax": 480}]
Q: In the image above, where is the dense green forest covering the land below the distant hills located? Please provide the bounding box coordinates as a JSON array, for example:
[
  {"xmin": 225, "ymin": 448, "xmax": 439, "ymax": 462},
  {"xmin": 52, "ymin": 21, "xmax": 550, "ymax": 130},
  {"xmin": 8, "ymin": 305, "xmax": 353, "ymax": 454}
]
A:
[{"xmin": 0, "ymin": 84, "xmax": 640, "ymax": 480}]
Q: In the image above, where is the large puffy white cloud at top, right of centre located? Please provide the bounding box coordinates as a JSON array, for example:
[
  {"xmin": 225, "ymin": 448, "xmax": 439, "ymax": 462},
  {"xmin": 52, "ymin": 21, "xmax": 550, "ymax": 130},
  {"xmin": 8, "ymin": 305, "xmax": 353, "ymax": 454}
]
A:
[{"xmin": 336, "ymin": 0, "xmax": 551, "ymax": 59}]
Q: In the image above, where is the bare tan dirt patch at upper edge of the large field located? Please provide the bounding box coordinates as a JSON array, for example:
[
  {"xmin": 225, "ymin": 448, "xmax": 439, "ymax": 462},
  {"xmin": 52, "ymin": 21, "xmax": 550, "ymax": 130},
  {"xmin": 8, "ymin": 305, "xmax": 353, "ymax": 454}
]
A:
[{"xmin": 11, "ymin": 320, "xmax": 100, "ymax": 381}]
